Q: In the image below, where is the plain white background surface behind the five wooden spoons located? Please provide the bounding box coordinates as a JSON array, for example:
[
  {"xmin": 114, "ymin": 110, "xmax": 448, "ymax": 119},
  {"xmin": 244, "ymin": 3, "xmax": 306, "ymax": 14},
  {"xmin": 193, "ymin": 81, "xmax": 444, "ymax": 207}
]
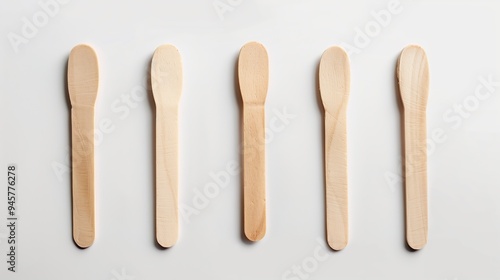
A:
[{"xmin": 0, "ymin": 0, "xmax": 500, "ymax": 280}]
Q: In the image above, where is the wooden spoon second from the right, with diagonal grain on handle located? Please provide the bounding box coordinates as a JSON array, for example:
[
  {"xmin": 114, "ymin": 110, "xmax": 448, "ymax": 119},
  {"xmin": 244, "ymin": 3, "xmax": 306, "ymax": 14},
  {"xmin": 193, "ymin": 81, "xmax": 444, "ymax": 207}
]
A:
[{"xmin": 319, "ymin": 47, "xmax": 350, "ymax": 250}]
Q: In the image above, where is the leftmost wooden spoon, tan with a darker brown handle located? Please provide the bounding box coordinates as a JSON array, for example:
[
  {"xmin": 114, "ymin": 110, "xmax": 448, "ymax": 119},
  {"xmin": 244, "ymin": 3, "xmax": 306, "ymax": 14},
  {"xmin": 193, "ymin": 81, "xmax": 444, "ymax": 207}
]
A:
[{"xmin": 68, "ymin": 45, "xmax": 99, "ymax": 248}]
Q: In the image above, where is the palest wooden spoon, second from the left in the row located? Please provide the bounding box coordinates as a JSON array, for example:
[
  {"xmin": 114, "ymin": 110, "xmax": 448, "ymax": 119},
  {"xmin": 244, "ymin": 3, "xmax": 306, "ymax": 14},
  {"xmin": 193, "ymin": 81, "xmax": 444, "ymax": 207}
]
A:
[{"xmin": 151, "ymin": 45, "xmax": 182, "ymax": 248}]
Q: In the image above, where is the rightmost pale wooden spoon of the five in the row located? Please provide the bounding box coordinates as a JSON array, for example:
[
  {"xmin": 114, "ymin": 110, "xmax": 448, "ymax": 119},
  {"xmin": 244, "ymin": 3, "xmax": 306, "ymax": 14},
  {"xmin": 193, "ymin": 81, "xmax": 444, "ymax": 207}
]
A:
[{"xmin": 397, "ymin": 46, "xmax": 429, "ymax": 250}]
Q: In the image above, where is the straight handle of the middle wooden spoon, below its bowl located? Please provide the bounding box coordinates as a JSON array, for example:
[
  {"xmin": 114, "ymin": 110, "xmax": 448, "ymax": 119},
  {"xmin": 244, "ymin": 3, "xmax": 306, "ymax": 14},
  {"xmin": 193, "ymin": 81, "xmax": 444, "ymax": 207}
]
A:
[{"xmin": 243, "ymin": 104, "xmax": 266, "ymax": 241}]
